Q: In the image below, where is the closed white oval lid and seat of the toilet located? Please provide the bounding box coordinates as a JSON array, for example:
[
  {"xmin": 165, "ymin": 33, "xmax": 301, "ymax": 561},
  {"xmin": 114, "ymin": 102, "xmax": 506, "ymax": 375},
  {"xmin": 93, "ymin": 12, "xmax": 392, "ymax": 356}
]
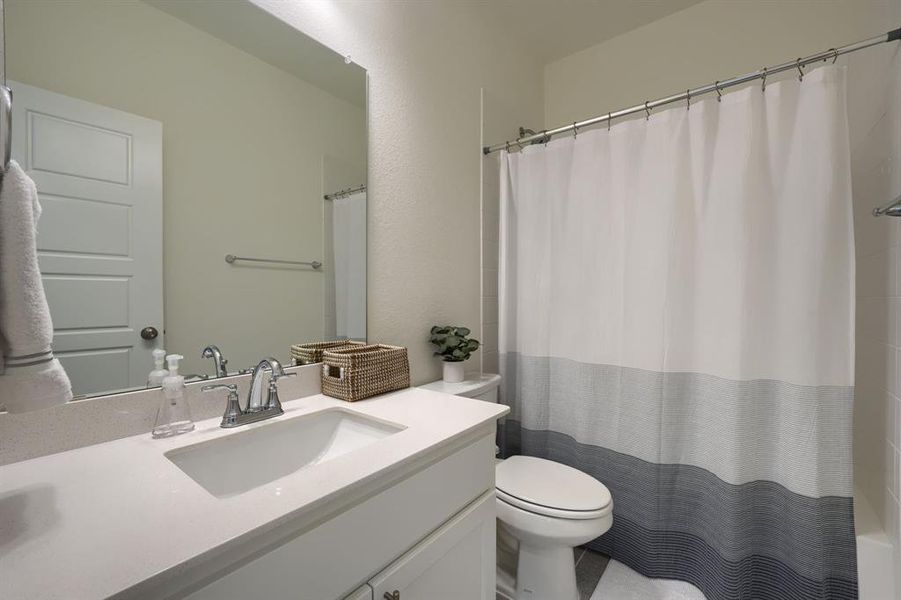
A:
[{"xmin": 495, "ymin": 456, "xmax": 613, "ymax": 518}]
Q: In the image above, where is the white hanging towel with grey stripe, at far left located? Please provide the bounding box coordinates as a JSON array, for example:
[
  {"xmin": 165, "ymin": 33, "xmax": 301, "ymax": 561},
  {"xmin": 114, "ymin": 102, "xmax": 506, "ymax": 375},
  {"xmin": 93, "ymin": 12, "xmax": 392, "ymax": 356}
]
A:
[{"xmin": 0, "ymin": 161, "xmax": 72, "ymax": 413}]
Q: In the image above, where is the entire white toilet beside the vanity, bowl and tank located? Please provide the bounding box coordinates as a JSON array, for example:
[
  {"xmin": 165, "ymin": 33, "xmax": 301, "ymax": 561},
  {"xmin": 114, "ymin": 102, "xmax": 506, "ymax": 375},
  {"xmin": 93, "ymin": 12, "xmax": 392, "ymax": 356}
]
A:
[{"xmin": 422, "ymin": 375, "xmax": 613, "ymax": 600}]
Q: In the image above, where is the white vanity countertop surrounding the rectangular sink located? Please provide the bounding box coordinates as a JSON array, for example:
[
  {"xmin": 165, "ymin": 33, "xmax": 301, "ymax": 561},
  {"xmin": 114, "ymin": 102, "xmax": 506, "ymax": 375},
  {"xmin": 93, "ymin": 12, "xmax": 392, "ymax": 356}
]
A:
[{"xmin": 0, "ymin": 388, "xmax": 508, "ymax": 600}]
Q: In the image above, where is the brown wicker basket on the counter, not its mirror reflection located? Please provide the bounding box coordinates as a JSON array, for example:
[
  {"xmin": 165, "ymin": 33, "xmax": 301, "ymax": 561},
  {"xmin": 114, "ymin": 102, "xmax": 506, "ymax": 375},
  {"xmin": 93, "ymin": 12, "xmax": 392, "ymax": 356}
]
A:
[{"xmin": 322, "ymin": 344, "xmax": 410, "ymax": 402}]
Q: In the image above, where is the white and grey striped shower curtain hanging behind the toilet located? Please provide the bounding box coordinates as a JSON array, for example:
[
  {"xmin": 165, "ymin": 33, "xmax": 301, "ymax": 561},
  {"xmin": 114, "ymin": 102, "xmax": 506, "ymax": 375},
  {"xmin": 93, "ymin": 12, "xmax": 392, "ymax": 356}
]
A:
[{"xmin": 499, "ymin": 66, "xmax": 857, "ymax": 600}]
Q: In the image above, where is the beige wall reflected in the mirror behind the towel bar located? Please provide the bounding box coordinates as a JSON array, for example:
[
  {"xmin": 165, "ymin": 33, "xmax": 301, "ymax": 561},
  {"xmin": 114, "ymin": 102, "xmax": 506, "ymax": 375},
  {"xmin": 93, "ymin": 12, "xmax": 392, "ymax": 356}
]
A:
[{"xmin": 6, "ymin": 0, "xmax": 366, "ymax": 373}]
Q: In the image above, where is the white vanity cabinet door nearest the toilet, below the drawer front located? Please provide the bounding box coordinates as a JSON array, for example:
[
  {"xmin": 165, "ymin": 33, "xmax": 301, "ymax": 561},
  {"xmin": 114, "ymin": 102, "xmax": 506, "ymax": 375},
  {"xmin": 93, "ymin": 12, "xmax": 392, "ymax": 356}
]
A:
[{"xmin": 369, "ymin": 490, "xmax": 496, "ymax": 600}]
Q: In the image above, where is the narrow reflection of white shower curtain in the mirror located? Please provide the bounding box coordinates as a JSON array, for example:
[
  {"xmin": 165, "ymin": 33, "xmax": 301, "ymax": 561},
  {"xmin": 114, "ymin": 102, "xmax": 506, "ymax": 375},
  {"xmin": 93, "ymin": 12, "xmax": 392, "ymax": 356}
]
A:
[{"xmin": 332, "ymin": 192, "xmax": 366, "ymax": 341}]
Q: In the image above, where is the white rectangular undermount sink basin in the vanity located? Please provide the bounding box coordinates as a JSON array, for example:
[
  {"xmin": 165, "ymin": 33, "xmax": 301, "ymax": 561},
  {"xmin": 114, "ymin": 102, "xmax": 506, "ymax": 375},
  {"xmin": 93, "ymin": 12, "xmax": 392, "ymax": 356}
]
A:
[{"xmin": 165, "ymin": 408, "xmax": 404, "ymax": 498}]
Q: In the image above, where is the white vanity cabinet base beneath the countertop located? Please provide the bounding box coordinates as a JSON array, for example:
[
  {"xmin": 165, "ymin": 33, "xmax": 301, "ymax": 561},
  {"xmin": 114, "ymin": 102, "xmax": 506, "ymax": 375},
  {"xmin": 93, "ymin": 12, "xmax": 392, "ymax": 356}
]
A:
[{"xmin": 182, "ymin": 434, "xmax": 496, "ymax": 600}]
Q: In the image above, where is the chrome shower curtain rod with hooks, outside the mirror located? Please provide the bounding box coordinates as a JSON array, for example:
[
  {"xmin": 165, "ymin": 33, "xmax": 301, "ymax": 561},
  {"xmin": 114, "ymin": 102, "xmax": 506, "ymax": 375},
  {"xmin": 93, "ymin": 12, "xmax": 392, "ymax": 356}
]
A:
[{"xmin": 482, "ymin": 28, "xmax": 901, "ymax": 154}]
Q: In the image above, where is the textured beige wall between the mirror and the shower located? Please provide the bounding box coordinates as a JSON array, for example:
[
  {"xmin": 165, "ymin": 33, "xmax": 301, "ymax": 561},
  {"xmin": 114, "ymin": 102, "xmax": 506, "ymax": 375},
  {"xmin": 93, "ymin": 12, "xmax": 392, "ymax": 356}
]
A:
[{"xmin": 254, "ymin": 0, "xmax": 543, "ymax": 383}]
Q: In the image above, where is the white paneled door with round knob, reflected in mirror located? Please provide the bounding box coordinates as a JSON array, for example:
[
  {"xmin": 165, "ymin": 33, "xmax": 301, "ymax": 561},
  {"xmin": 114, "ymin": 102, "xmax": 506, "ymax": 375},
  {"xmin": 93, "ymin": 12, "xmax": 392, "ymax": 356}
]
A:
[{"xmin": 9, "ymin": 81, "xmax": 163, "ymax": 395}]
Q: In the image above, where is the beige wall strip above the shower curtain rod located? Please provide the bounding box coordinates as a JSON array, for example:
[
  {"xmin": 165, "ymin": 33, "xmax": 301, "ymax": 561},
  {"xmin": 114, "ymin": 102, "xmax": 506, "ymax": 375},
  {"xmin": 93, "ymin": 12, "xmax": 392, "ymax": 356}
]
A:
[{"xmin": 545, "ymin": 0, "xmax": 898, "ymax": 127}]
